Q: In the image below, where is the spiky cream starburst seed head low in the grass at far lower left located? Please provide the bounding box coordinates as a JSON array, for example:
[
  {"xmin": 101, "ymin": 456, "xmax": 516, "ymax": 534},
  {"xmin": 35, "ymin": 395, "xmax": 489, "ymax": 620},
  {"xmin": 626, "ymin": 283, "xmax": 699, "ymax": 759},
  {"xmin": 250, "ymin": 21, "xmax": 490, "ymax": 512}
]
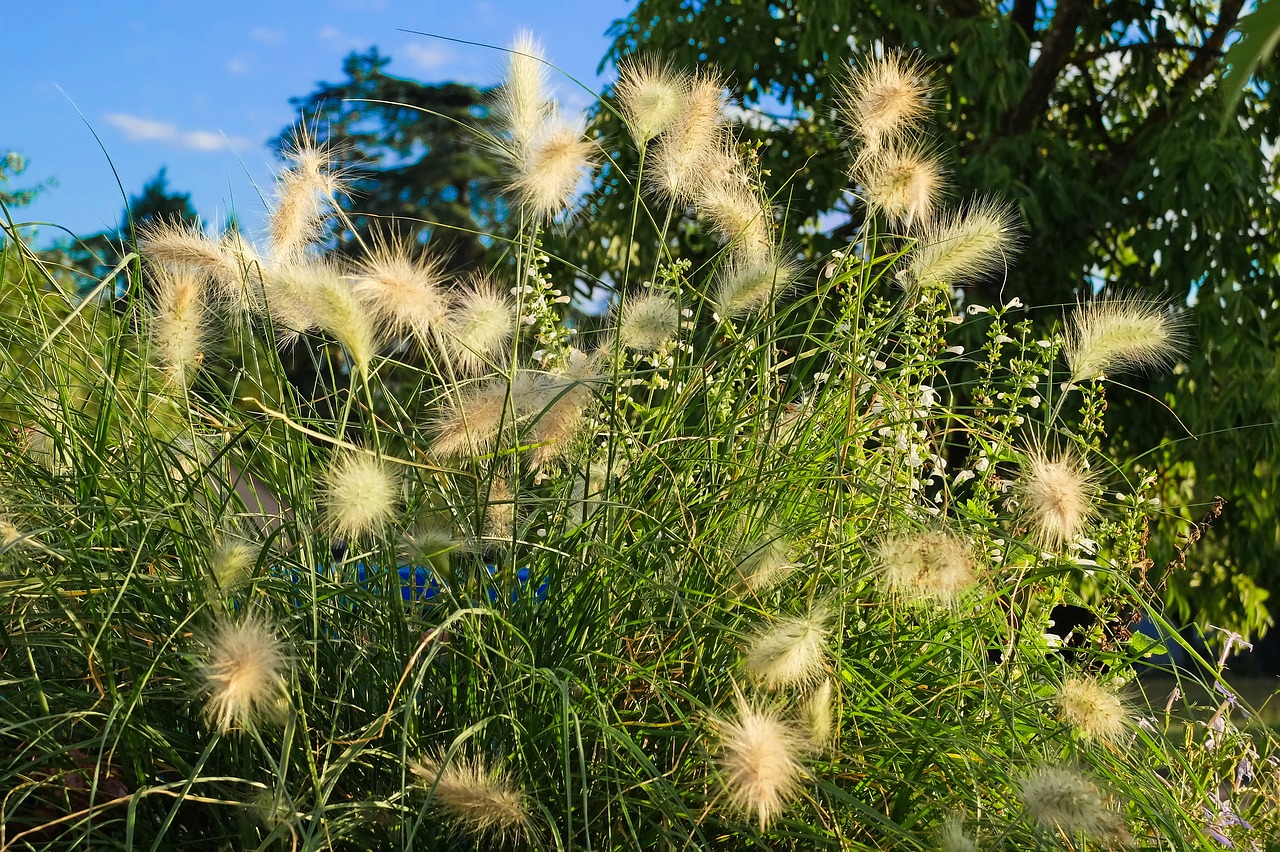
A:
[{"xmin": 201, "ymin": 614, "xmax": 288, "ymax": 733}]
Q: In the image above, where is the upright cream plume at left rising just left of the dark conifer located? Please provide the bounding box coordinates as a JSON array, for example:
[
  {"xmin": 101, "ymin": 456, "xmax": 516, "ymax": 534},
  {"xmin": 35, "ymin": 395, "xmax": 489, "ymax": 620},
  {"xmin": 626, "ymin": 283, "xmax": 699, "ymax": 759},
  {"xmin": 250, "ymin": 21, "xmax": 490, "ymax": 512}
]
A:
[{"xmin": 268, "ymin": 140, "xmax": 344, "ymax": 261}]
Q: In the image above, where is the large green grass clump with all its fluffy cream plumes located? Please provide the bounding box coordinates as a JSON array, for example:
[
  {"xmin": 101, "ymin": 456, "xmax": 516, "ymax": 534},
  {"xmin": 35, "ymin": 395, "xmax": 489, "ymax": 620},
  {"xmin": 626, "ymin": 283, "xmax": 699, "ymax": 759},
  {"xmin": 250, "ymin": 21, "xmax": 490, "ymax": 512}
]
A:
[{"xmin": 0, "ymin": 43, "xmax": 1277, "ymax": 851}]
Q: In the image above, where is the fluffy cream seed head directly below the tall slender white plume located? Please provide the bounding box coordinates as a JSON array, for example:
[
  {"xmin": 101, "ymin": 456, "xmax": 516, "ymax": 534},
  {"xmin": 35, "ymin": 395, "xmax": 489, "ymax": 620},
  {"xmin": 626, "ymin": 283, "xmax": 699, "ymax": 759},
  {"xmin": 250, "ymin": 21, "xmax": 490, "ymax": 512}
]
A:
[{"xmin": 512, "ymin": 115, "xmax": 594, "ymax": 219}]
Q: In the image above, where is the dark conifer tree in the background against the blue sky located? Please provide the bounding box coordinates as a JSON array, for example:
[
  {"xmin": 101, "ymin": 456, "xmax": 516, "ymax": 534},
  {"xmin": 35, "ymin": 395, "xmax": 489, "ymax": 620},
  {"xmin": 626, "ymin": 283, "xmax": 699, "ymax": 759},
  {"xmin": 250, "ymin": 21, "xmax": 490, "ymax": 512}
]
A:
[{"xmin": 273, "ymin": 47, "xmax": 504, "ymax": 269}]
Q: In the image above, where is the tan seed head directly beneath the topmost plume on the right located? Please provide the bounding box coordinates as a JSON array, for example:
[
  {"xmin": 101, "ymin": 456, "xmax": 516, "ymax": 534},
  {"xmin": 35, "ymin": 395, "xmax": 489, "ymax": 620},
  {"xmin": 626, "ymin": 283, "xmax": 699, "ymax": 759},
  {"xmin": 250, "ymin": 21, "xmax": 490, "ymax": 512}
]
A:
[{"xmin": 852, "ymin": 146, "xmax": 943, "ymax": 228}]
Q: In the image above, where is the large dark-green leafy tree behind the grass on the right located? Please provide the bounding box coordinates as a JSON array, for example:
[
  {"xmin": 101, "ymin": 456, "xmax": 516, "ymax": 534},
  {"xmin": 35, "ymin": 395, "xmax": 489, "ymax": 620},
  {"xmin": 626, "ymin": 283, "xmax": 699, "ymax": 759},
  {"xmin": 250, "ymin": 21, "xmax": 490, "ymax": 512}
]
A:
[{"xmin": 596, "ymin": 0, "xmax": 1280, "ymax": 631}]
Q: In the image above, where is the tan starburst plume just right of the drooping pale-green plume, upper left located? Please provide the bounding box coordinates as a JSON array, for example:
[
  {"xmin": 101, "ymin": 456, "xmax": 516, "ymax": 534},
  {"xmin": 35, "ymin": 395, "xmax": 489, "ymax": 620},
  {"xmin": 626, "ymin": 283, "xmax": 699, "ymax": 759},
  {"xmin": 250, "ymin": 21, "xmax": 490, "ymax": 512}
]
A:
[{"xmin": 352, "ymin": 246, "xmax": 449, "ymax": 340}]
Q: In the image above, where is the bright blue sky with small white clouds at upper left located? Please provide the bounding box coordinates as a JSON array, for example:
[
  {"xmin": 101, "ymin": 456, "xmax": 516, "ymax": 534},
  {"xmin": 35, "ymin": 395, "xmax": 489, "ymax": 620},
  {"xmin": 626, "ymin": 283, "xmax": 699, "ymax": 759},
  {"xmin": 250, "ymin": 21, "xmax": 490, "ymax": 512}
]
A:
[{"xmin": 0, "ymin": 0, "xmax": 631, "ymax": 244}]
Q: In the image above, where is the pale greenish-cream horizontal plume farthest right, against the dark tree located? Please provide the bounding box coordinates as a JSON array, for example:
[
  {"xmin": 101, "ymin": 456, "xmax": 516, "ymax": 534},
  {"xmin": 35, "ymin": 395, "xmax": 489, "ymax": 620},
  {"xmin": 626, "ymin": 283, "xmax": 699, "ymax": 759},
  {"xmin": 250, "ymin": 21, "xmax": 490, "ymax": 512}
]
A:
[{"xmin": 1064, "ymin": 296, "xmax": 1185, "ymax": 384}]
